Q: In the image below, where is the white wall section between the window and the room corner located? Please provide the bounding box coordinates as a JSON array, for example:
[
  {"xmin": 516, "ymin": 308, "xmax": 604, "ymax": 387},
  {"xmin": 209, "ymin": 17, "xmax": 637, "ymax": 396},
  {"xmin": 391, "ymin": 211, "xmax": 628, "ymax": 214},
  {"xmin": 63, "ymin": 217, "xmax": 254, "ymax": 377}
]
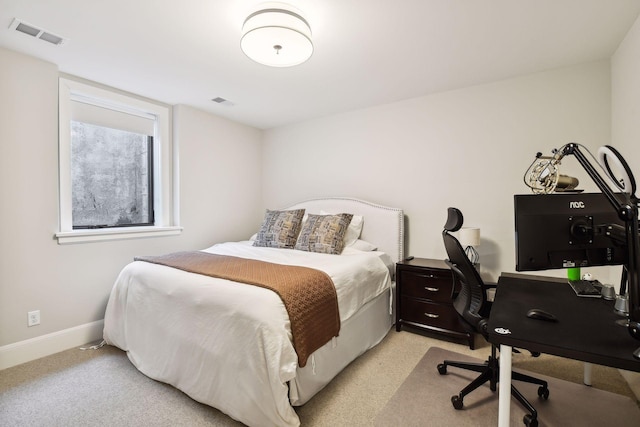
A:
[{"xmin": 174, "ymin": 106, "xmax": 264, "ymax": 248}]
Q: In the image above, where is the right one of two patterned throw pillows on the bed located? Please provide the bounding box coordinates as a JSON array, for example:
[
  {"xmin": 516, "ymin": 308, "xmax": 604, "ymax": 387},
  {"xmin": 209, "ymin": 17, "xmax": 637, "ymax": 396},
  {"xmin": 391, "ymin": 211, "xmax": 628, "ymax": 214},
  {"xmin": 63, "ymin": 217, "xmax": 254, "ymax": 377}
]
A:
[{"xmin": 295, "ymin": 213, "xmax": 353, "ymax": 255}]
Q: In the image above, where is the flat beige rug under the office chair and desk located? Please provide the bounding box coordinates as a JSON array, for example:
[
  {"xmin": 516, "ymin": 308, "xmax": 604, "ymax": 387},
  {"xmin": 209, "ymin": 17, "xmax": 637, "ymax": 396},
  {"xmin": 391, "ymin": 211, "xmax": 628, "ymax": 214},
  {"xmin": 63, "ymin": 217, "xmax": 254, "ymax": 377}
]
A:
[{"xmin": 374, "ymin": 347, "xmax": 640, "ymax": 427}]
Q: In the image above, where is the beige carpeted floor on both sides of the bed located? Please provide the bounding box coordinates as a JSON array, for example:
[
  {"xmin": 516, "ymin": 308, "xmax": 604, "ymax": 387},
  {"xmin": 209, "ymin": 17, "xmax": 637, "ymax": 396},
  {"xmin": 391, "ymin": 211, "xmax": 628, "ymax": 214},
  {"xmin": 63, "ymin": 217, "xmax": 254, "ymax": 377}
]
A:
[{"xmin": 0, "ymin": 331, "xmax": 640, "ymax": 427}]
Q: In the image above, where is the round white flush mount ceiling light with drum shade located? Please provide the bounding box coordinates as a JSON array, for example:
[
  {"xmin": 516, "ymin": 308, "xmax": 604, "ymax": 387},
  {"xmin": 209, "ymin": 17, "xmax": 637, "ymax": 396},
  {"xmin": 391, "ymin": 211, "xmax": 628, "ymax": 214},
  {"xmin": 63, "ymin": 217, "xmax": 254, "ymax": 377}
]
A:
[{"xmin": 240, "ymin": 3, "xmax": 313, "ymax": 67}]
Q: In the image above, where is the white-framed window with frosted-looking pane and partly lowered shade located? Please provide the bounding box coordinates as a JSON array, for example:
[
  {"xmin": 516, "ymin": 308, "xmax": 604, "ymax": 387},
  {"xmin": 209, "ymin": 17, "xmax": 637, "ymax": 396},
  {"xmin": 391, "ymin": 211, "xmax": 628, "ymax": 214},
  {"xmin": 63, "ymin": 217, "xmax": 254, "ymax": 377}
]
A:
[{"xmin": 56, "ymin": 78, "xmax": 181, "ymax": 244}]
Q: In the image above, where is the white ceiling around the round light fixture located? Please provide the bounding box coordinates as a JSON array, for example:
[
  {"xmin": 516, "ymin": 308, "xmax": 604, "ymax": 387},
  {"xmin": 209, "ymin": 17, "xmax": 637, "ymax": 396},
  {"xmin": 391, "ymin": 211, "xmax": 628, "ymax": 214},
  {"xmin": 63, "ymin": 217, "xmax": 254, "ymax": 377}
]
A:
[{"xmin": 0, "ymin": 0, "xmax": 640, "ymax": 129}]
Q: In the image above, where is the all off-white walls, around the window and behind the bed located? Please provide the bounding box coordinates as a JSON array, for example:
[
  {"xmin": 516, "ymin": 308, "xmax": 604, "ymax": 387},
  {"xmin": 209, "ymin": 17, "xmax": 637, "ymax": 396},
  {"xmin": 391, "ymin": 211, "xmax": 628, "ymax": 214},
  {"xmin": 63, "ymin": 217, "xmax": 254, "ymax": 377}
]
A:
[{"xmin": 0, "ymin": 23, "xmax": 640, "ymax": 368}]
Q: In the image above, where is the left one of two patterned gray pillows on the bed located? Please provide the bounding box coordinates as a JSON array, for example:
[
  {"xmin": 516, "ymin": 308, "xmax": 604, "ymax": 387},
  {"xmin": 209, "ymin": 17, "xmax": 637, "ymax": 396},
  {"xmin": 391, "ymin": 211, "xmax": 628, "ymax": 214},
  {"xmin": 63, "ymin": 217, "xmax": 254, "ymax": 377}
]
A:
[{"xmin": 253, "ymin": 209, "xmax": 304, "ymax": 248}]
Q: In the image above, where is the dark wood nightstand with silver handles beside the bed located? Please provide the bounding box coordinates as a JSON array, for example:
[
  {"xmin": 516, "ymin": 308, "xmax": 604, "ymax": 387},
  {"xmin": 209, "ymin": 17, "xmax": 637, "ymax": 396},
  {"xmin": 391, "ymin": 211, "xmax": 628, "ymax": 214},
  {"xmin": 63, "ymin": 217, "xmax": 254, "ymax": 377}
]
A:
[{"xmin": 396, "ymin": 258, "xmax": 474, "ymax": 350}]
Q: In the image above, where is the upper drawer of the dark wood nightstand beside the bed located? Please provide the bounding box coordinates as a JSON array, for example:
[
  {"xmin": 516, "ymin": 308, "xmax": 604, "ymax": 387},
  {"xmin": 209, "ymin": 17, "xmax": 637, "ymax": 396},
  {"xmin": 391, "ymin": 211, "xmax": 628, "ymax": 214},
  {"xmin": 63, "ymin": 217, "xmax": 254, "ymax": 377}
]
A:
[{"xmin": 400, "ymin": 270, "xmax": 453, "ymax": 304}]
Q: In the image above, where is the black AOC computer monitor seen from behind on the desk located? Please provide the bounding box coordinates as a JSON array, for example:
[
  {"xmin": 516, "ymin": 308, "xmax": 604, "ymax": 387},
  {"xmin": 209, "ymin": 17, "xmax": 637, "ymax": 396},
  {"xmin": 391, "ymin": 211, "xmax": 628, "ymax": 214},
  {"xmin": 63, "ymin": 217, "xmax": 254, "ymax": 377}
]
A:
[{"xmin": 514, "ymin": 193, "xmax": 627, "ymax": 271}]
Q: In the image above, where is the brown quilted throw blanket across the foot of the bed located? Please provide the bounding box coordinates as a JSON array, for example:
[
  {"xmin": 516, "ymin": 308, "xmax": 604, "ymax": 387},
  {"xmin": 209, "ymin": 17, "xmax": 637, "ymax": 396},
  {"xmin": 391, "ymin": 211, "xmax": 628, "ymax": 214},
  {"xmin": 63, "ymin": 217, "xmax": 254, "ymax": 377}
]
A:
[{"xmin": 135, "ymin": 251, "xmax": 340, "ymax": 367}]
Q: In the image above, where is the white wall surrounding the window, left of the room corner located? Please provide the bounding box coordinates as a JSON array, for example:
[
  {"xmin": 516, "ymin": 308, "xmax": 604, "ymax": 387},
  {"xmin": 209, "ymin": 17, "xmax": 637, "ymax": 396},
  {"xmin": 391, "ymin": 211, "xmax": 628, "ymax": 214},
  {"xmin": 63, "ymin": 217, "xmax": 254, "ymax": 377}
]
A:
[{"xmin": 0, "ymin": 48, "xmax": 263, "ymax": 369}]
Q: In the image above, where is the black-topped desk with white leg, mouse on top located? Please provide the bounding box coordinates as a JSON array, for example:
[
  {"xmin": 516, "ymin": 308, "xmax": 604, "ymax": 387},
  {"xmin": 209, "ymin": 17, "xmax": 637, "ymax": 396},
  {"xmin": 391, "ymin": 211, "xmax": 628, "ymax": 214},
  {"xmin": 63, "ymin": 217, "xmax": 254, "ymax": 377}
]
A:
[{"xmin": 489, "ymin": 273, "xmax": 640, "ymax": 427}]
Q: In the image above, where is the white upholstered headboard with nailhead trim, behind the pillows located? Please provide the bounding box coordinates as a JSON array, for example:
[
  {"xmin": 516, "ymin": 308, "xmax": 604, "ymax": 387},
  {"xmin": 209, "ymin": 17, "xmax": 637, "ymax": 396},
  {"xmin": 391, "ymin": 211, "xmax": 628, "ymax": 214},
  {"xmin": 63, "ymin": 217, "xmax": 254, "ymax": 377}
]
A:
[{"xmin": 285, "ymin": 197, "xmax": 404, "ymax": 262}]
